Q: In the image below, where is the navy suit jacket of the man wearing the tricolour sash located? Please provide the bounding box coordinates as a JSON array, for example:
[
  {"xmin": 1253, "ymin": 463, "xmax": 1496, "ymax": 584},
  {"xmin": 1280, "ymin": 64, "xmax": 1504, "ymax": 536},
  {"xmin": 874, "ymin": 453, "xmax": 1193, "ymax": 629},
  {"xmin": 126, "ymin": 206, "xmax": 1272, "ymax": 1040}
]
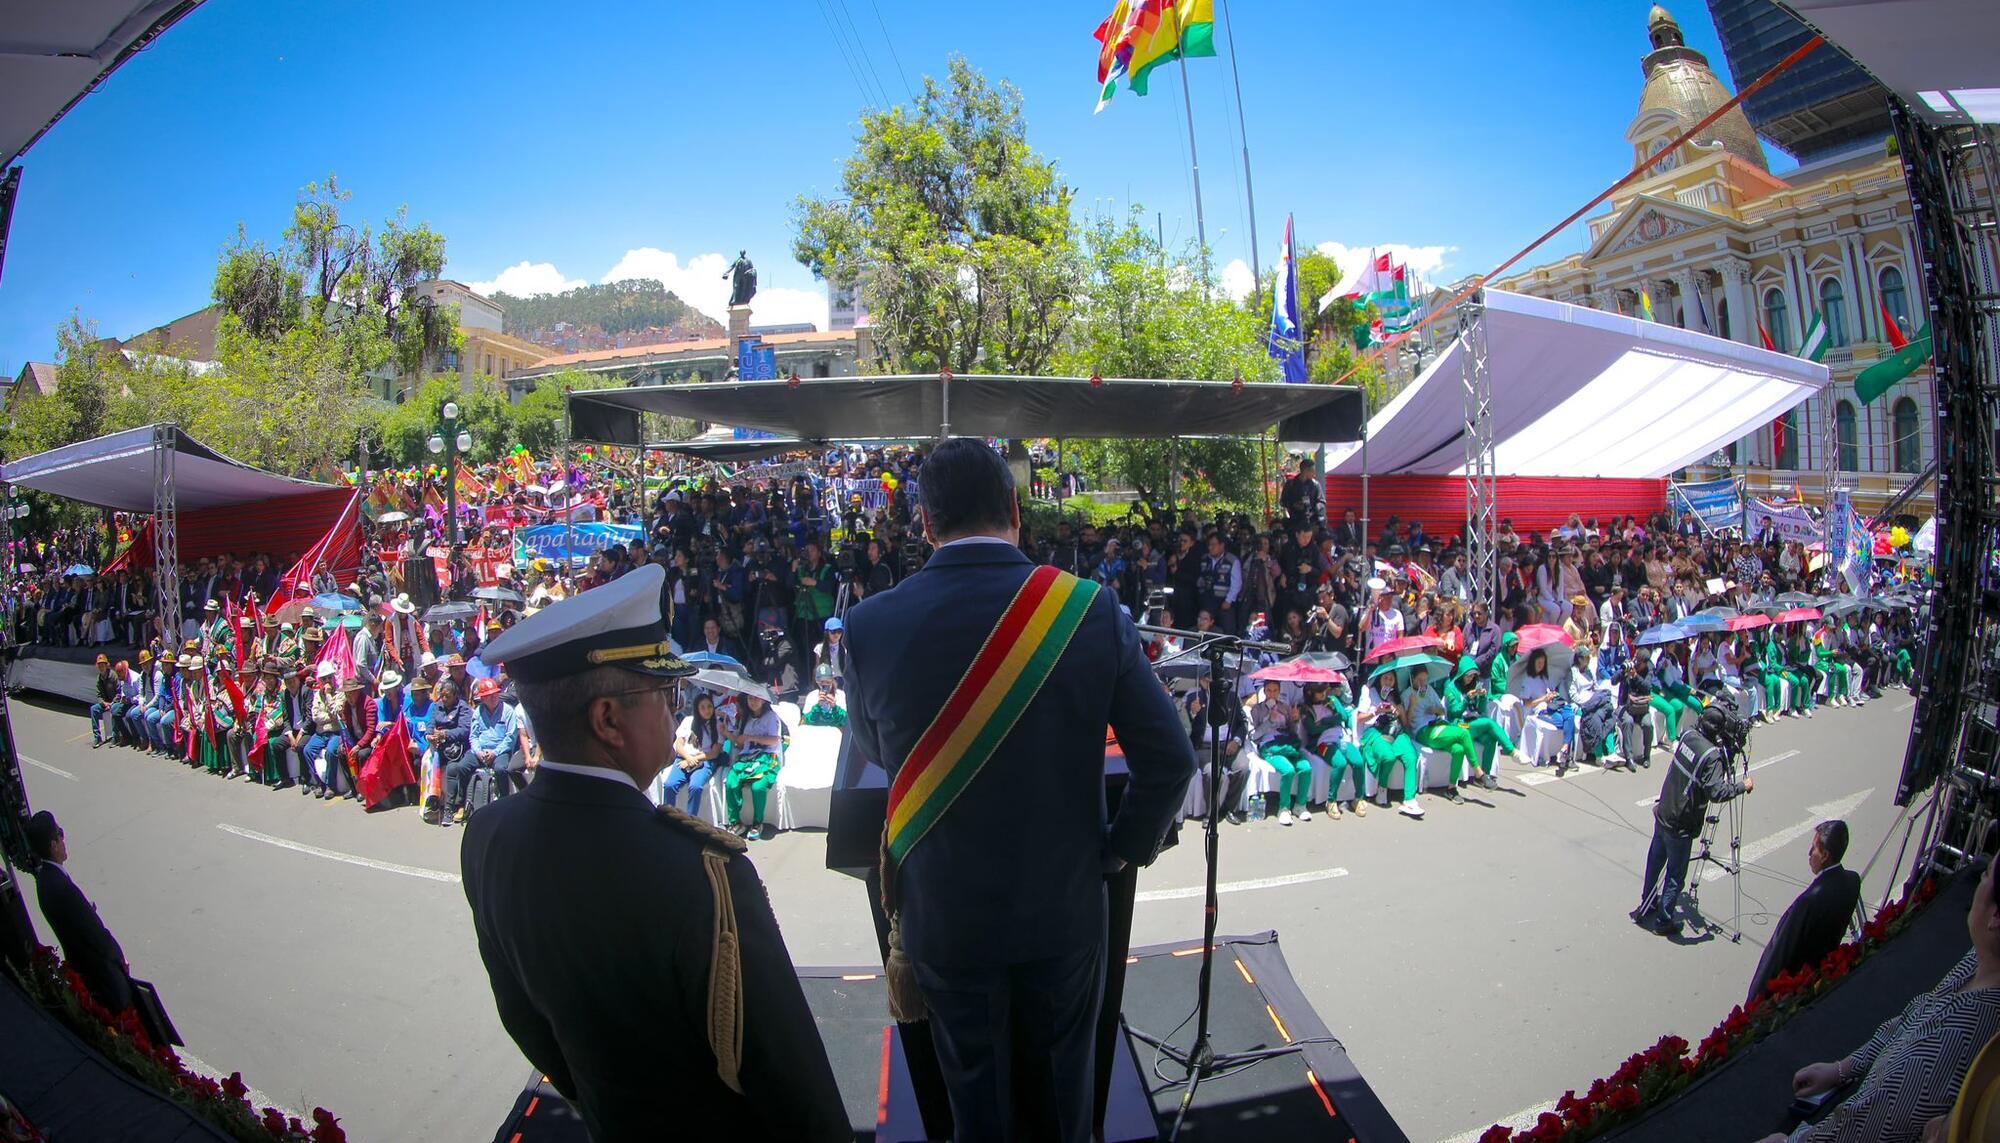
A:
[{"xmin": 846, "ymin": 544, "xmax": 1194, "ymax": 965}]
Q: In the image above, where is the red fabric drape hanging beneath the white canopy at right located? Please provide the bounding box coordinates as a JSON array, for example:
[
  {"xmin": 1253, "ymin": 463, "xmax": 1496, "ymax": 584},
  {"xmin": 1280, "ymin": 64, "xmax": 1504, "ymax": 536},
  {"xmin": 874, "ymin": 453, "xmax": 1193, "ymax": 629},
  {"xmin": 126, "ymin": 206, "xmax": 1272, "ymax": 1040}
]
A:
[{"xmin": 1326, "ymin": 476, "xmax": 1666, "ymax": 540}]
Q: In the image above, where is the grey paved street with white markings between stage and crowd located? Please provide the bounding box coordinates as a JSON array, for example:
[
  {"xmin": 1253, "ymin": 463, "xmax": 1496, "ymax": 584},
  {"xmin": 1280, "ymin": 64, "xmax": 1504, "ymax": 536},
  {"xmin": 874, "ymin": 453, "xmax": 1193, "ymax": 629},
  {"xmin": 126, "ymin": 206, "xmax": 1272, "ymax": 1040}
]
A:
[{"xmin": 12, "ymin": 693, "xmax": 1912, "ymax": 1141}]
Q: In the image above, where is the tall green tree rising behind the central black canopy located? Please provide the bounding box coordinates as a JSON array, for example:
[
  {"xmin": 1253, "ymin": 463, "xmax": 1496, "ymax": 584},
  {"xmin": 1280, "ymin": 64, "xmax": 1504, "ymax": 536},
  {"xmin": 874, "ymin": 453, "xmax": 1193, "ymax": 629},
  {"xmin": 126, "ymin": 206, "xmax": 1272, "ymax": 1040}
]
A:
[{"xmin": 792, "ymin": 56, "xmax": 1082, "ymax": 374}]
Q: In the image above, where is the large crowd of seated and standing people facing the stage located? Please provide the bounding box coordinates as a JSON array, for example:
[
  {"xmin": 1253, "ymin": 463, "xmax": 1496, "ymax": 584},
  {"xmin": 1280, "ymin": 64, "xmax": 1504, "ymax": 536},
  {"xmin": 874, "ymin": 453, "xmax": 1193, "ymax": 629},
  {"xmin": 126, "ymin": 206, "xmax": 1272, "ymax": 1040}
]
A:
[{"xmin": 12, "ymin": 450, "xmax": 1922, "ymax": 833}]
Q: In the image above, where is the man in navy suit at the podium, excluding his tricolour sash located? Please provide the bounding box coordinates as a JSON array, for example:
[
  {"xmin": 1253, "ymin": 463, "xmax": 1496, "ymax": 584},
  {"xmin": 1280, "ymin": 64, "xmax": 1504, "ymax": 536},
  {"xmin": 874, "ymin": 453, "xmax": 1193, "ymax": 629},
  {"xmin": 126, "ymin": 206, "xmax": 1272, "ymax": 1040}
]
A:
[{"xmin": 846, "ymin": 440, "xmax": 1194, "ymax": 1143}]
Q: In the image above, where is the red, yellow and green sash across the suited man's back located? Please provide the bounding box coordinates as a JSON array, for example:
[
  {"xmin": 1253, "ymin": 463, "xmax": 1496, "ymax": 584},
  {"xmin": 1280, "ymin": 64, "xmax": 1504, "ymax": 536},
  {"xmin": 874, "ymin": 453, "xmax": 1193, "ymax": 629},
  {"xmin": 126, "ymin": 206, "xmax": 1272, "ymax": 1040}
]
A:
[{"xmin": 882, "ymin": 568, "xmax": 1098, "ymax": 873}]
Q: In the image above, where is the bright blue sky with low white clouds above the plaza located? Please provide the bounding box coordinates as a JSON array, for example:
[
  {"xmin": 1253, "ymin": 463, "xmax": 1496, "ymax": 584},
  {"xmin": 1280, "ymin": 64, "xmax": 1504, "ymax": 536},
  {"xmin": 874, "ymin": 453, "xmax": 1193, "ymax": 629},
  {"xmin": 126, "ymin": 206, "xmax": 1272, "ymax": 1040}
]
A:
[{"xmin": 0, "ymin": 0, "xmax": 1784, "ymax": 376}]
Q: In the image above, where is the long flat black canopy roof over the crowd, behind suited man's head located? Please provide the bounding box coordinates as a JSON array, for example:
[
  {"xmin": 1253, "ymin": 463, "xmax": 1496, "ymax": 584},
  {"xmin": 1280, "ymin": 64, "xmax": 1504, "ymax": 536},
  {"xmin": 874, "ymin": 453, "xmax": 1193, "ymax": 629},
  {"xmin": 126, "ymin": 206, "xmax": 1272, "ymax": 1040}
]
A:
[{"xmin": 570, "ymin": 374, "xmax": 1362, "ymax": 448}]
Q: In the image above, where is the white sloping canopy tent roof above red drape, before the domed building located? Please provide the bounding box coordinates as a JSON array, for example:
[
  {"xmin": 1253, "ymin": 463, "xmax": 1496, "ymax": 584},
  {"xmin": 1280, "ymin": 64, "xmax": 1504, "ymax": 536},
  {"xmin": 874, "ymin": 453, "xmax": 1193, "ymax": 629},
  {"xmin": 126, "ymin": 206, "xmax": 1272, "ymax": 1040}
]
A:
[{"xmin": 1326, "ymin": 290, "xmax": 1828, "ymax": 478}]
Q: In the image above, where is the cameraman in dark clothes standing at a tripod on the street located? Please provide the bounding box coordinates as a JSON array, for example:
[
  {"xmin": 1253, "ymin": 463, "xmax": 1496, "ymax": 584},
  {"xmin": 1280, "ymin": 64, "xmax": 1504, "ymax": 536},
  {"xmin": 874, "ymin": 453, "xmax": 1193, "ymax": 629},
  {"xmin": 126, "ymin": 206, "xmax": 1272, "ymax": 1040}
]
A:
[{"xmin": 1630, "ymin": 707, "xmax": 1756, "ymax": 937}]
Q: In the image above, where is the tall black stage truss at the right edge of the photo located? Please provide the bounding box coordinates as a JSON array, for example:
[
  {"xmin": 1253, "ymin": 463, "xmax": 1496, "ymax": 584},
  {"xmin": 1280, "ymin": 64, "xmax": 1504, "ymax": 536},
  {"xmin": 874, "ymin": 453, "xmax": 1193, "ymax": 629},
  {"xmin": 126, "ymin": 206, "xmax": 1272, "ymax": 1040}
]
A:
[{"xmin": 1892, "ymin": 104, "xmax": 2000, "ymax": 879}]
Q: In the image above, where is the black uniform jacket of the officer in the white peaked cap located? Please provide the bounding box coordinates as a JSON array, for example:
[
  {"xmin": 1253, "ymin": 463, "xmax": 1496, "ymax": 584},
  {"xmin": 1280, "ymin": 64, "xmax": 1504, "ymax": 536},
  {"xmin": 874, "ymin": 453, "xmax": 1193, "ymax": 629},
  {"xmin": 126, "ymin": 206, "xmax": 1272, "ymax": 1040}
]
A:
[{"xmin": 458, "ymin": 769, "xmax": 854, "ymax": 1143}]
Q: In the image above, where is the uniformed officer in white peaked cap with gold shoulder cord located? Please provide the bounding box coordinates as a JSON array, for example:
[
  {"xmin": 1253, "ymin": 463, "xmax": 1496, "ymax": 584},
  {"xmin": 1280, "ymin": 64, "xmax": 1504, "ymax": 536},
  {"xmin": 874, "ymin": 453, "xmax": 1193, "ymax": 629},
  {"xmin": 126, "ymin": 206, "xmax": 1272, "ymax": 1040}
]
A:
[{"xmin": 460, "ymin": 564, "xmax": 854, "ymax": 1143}]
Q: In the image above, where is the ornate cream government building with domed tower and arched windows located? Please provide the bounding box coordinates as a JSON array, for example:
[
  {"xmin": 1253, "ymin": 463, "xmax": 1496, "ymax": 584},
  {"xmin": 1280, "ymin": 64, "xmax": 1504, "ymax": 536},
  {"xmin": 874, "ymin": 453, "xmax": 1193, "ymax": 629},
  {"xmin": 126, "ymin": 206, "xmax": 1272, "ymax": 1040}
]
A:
[{"xmin": 1494, "ymin": 6, "xmax": 1932, "ymax": 512}]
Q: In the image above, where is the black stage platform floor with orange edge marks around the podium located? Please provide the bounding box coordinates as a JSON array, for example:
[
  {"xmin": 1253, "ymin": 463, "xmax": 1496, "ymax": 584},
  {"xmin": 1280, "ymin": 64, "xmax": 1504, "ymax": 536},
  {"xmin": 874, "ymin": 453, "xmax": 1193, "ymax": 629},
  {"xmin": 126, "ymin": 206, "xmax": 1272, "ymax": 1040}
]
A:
[{"xmin": 494, "ymin": 933, "xmax": 1406, "ymax": 1143}]
